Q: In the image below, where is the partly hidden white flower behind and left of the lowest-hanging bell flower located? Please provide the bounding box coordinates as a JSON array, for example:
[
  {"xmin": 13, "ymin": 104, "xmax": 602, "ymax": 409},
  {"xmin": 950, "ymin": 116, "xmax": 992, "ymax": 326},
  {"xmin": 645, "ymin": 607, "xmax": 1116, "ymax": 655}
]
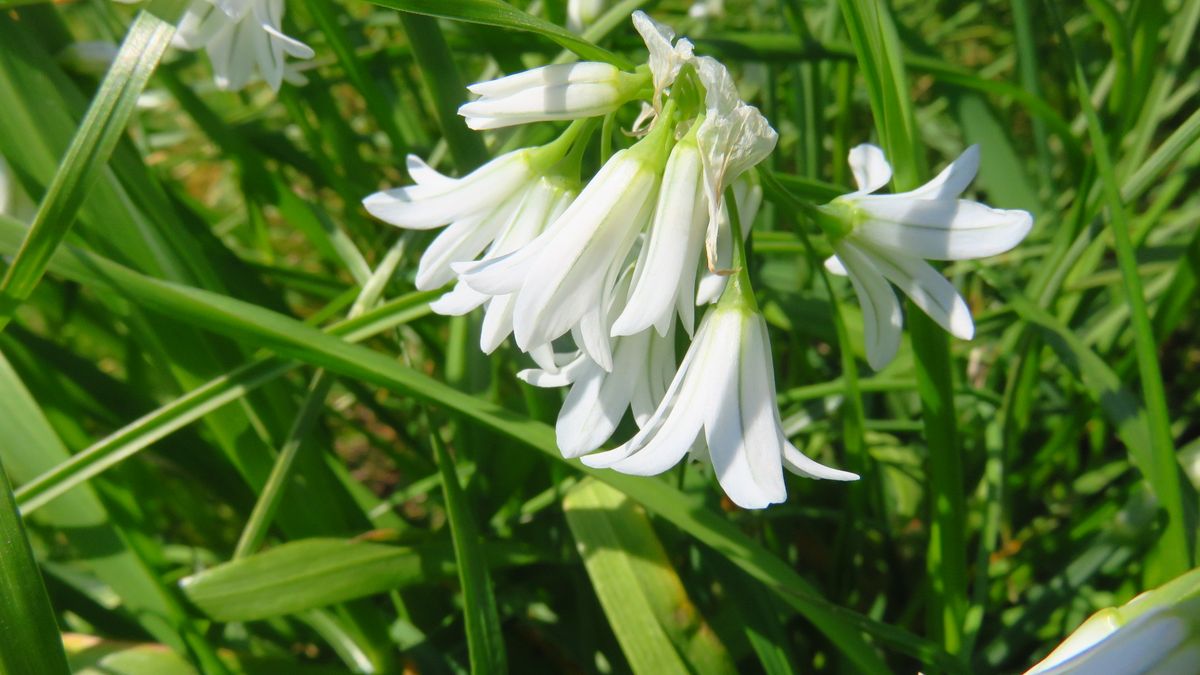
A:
[{"xmin": 517, "ymin": 267, "xmax": 676, "ymax": 458}]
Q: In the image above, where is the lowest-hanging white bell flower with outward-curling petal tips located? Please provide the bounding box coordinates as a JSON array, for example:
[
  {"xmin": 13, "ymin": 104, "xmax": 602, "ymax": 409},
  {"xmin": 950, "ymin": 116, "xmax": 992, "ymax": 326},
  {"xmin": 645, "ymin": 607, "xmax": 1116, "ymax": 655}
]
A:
[{"xmin": 582, "ymin": 296, "xmax": 858, "ymax": 508}]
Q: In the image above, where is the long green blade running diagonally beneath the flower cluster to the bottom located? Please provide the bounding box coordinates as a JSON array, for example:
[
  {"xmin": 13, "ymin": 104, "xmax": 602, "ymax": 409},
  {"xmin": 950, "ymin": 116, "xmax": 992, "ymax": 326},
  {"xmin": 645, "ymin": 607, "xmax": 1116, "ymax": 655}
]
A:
[{"xmin": 0, "ymin": 213, "xmax": 940, "ymax": 671}]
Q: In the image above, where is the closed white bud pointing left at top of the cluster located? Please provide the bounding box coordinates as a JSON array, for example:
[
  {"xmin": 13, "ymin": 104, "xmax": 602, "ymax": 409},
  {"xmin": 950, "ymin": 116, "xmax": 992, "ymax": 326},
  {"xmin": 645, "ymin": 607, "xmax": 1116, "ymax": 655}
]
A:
[{"xmin": 458, "ymin": 61, "xmax": 646, "ymax": 130}]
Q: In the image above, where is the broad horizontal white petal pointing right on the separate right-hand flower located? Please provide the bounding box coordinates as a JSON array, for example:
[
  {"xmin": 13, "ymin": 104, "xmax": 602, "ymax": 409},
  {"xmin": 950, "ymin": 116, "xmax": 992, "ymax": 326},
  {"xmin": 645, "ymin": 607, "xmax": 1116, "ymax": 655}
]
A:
[{"xmin": 854, "ymin": 195, "xmax": 1033, "ymax": 261}]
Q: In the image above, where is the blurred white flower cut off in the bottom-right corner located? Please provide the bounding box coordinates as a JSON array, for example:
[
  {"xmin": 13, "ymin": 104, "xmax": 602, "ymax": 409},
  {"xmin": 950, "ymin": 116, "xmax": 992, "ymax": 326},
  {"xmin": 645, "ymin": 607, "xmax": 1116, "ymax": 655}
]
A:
[{"xmin": 1025, "ymin": 569, "xmax": 1200, "ymax": 675}]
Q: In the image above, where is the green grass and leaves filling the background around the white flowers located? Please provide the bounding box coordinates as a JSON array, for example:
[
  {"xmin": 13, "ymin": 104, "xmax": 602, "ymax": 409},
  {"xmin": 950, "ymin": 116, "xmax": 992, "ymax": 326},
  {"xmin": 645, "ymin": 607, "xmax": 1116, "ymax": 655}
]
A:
[{"xmin": 0, "ymin": 0, "xmax": 1200, "ymax": 674}]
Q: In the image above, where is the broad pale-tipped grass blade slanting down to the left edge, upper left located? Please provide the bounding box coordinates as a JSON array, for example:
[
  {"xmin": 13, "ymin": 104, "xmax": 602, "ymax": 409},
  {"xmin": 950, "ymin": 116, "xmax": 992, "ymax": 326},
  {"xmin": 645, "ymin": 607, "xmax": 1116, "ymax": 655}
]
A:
[{"xmin": 0, "ymin": 12, "xmax": 175, "ymax": 329}]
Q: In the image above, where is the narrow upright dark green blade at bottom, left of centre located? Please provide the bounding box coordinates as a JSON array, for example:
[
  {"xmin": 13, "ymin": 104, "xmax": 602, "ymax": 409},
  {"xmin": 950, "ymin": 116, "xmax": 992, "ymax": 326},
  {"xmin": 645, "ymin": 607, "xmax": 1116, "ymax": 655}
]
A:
[{"xmin": 430, "ymin": 432, "xmax": 508, "ymax": 675}]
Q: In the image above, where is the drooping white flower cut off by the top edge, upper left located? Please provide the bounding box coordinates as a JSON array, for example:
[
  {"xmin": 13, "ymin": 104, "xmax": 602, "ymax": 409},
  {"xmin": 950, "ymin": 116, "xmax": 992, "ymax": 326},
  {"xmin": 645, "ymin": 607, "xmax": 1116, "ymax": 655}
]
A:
[{"xmin": 174, "ymin": 0, "xmax": 313, "ymax": 90}]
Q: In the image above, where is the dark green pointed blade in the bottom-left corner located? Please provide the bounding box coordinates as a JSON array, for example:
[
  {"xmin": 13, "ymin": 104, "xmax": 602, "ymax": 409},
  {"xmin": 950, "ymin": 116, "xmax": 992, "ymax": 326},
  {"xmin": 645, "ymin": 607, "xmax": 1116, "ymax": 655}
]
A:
[{"xmin": 0, "ymin": 456, "xmax": 71, "ymax": 675}]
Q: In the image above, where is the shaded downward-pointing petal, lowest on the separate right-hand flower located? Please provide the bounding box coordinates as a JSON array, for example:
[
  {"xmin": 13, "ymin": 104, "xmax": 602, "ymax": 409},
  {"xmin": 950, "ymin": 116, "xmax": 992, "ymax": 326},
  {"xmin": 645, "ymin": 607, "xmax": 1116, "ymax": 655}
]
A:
[{"xmin": 835, "ymin": 240, "xmax": 904, "ymax": 370}]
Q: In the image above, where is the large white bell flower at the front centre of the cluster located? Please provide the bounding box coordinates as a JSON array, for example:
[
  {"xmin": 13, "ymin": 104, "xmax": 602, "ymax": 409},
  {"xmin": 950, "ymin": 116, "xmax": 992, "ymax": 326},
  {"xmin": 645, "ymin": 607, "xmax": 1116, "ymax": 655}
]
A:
[{"xmin": 462, "ymin": 114, "xmax": 672, "ymax": 371}]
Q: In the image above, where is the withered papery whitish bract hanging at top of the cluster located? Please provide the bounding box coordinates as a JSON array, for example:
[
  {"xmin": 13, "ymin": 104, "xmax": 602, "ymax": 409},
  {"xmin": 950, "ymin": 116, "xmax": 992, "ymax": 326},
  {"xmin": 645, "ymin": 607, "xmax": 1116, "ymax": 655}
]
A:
[{"xmin": 694, "ymin": 56, "xmax": 779, "ymax": 271}]
